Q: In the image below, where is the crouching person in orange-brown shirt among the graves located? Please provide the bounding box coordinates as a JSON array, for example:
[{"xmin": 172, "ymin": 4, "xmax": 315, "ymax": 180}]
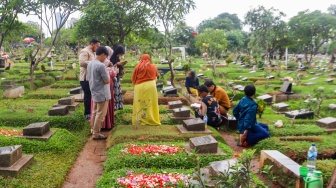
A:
[{"xmin": 204, "ymin": 80, "xmax": 231, "ymax": 116}]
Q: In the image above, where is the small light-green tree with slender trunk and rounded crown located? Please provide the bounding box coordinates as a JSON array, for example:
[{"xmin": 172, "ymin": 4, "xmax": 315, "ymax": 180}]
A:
[{"xmin": 196, "ymin": 29, "xmax": 228, "ymax": 76}]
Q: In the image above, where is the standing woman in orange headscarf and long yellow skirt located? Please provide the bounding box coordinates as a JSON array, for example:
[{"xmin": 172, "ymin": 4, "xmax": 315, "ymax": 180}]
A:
[{"xmin": 132, "ymin": 54, "xmax": 161, "ymax": 126}]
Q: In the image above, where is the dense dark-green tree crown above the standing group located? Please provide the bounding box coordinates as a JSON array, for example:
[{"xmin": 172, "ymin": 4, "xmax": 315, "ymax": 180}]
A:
[{"xmin": 77, "ymin": 0, "xmax": 150, "ymax": 45}]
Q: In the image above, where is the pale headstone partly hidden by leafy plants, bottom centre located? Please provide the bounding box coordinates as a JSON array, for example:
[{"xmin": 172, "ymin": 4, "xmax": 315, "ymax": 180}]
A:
[{"xmin": 209, "ymin": 159, "xmax": 238, "ymax": 177}]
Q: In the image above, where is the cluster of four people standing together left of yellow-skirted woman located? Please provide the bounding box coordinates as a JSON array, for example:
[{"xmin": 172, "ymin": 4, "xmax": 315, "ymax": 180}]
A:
[{"xmin": 78, "ymin": 39, "xmax": 126, "ymax": 140}]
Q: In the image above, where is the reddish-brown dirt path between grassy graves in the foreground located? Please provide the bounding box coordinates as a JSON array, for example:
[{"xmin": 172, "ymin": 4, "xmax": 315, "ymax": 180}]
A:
[{"xmin": 63, "ymin": 132, "xmax": 110, "ymax": 188}]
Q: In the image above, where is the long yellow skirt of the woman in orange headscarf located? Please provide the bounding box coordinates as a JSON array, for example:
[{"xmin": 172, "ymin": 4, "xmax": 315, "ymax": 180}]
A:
[{"xmin": 132, "ymin": 80, "xmax": 161, "ymax": 126}]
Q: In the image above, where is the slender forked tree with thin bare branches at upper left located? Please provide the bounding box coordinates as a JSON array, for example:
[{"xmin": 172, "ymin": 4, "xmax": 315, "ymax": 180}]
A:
[{"xmin": 27, "ymin": 0, "xmax": 82, "ymax": 89}]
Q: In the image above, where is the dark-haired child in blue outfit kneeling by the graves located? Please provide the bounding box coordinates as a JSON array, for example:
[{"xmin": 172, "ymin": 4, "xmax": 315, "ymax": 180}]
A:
[{"xmin": 233, "ymin": 85, "xmax": 270, "ymax": 147}]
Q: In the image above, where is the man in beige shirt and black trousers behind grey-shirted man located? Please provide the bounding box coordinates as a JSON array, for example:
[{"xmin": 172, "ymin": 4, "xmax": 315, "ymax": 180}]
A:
[{"xmin": 78, "ymin": 39, "xmax": 100, "ymax": 119}]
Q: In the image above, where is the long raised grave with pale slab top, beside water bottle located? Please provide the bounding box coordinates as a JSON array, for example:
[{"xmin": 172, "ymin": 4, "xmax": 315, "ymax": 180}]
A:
[{"xmin": 259, "ymin": 150, "xmax": 305, "ymax": 188}]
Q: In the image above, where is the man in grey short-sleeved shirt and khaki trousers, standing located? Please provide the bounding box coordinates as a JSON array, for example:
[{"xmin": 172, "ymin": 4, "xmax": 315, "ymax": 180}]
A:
[{"xmin": 87, "ymin": 46, "xmax": 111, "ymax": 140}]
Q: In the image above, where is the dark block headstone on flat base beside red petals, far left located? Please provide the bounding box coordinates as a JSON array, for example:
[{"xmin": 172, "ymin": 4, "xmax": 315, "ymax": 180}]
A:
[{"xmin": 17, "ymin": 122, "xmax": 55, "ymax": 140}]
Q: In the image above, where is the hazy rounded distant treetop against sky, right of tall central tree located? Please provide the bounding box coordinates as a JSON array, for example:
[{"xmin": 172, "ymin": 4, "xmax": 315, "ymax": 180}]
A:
[{"xmin": 197, "ymin": 12, "xmax": 242, "ymax": 33}]
